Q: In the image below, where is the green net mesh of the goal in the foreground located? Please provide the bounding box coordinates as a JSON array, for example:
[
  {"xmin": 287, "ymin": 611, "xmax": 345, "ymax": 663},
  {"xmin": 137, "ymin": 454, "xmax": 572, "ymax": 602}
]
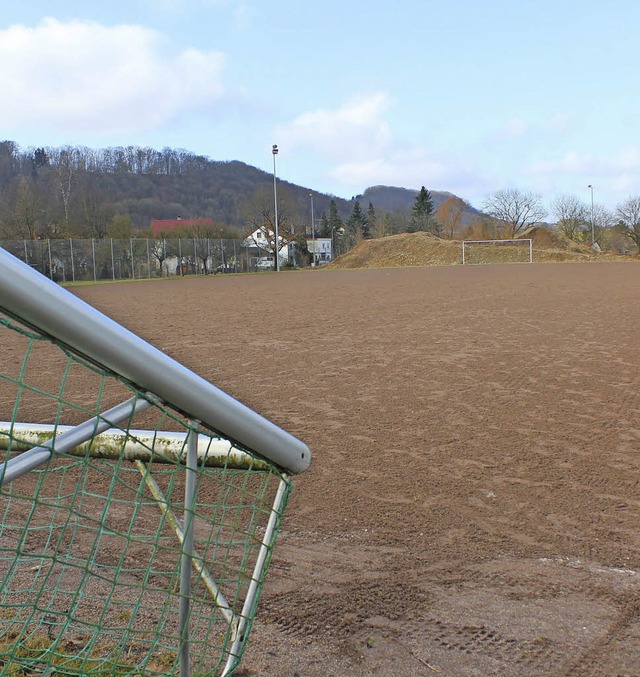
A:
[{"xmin": 0, "ymin": 314, "xmax": 291, "ymax": 675}]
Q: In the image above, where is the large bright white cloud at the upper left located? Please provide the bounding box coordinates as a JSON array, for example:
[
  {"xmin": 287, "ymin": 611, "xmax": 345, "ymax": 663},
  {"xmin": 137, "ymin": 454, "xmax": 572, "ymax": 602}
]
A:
[{"xmin": 0, "ymin": 18, "xmax": 224, "ymax": 133}]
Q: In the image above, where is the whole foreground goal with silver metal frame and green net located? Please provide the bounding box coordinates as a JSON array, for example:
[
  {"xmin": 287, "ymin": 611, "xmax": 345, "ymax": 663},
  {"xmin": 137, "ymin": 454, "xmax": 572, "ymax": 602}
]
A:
[{"xmin": 0, "ymin": 249, "xmax": 311, "ymax": 677}]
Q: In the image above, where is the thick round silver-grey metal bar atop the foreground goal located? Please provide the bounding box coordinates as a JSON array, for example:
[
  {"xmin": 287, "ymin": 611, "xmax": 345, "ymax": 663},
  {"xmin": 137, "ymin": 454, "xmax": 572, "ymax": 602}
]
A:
[{"xmin": 0, "ymin": 248, "xmax": 311, "ymax": 473}]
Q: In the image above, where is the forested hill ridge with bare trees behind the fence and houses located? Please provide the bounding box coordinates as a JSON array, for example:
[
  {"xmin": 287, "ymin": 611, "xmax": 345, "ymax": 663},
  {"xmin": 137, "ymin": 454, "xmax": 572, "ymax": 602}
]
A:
[{"xmin": 0, "ymin": 141, "xmax": 476, "ymax": 239}]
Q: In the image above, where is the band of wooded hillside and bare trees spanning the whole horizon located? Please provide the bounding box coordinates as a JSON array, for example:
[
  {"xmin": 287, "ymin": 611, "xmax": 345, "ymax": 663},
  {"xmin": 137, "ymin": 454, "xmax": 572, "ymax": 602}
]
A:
[{"xmin": 0, "ymin": 141, "xmax": 640, "ymax": 254}]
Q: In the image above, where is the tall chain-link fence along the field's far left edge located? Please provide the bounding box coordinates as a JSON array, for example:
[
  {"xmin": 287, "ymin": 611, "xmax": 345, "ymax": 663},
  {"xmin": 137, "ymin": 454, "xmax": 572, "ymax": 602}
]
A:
[{"xmin": 0, "ymin": 237, "xmax": 265, "ymax": 282}]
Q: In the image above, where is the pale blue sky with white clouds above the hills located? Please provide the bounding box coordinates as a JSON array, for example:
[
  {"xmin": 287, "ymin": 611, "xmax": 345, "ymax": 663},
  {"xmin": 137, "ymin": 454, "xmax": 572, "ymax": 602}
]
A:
[{"xmin": 0, "ymin": 0, "xmax": 640, "ymax": 209}]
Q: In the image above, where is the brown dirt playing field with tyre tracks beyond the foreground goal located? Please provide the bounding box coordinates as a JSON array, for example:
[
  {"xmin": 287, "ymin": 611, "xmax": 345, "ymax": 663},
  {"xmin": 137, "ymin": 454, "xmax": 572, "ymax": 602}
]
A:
[{"xmin": 73, "ymin": 263, "xmax": 640, "ymax": 677}]
